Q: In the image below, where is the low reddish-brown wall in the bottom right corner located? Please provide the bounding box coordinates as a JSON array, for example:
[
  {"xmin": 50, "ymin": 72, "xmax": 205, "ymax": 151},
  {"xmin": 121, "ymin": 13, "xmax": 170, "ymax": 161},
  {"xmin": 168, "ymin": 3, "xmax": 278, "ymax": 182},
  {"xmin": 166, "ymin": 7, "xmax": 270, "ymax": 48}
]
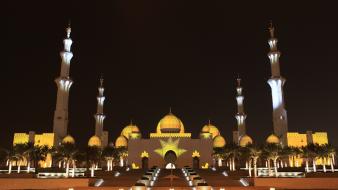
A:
[{"xmin": 253, "ymin": 178, "xmax": 338, "ymax": 189}]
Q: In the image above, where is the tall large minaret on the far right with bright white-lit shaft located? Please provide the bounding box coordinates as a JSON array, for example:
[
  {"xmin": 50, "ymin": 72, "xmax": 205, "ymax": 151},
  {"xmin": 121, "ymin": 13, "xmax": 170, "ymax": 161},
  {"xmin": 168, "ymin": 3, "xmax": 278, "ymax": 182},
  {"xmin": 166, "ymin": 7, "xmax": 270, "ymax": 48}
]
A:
[{"xmin": 268, "ymin": 23, "xmax": 288, "ymax": 145}]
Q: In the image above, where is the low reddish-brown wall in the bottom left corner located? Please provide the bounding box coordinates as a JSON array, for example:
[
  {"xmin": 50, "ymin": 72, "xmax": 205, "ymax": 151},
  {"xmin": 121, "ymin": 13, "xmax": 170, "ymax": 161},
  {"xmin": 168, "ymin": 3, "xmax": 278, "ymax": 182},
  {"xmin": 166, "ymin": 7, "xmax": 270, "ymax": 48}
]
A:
[{"xmin": 0, "ymin": 178, "xmax": 89, "ymax": 189}]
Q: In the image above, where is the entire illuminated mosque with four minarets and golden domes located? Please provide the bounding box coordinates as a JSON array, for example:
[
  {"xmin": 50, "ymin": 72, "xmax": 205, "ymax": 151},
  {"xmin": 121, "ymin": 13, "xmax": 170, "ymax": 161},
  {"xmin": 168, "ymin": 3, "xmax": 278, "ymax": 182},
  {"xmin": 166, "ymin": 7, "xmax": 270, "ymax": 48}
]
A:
[{"xmin": 13, "ymin": 24, "xmax": 328, "ymax": 168}]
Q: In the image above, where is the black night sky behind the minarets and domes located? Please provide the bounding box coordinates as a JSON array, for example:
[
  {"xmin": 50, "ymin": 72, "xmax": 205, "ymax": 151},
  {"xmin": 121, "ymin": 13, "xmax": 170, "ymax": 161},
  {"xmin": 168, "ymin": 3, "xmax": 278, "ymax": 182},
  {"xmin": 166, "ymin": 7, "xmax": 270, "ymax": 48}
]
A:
[{"xmin": 0, "ymin": 0, "xmax": 338, "ymax": 147}]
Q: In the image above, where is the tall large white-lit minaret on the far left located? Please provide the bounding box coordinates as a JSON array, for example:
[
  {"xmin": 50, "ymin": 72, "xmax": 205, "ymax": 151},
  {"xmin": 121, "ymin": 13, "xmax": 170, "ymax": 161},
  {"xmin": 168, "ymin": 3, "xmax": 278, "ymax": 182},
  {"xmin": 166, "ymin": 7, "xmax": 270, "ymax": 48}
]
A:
[{"xmin": 53, "ymin": 24, "xmax": 73, "ymax": 144}]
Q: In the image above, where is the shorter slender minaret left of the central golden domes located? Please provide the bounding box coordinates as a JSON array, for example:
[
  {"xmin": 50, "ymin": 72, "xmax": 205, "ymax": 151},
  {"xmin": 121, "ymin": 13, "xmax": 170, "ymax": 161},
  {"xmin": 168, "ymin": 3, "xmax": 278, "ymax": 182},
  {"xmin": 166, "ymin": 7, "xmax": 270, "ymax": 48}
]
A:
[{"xmin": 94, "ymin": 77, "xmax": 106, "ymax": 138}]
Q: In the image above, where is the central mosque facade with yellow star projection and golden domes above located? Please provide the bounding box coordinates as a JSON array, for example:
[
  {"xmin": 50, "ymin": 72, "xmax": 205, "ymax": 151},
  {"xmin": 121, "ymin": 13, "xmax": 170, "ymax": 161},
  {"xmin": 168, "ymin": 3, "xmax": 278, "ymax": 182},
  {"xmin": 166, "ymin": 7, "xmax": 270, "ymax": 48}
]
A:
[{"xmin": 115, "ymin": 112, "xmax": 226, "ymax": 168}]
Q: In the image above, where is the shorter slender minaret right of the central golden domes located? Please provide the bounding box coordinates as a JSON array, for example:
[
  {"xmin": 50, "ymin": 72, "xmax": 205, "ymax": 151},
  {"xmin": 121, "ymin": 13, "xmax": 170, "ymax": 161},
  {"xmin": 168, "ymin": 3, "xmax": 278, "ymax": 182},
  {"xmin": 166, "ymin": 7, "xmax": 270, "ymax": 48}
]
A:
[{"xmin": 235, "ymin": 77, "xmax": 246, "ymax": 138}]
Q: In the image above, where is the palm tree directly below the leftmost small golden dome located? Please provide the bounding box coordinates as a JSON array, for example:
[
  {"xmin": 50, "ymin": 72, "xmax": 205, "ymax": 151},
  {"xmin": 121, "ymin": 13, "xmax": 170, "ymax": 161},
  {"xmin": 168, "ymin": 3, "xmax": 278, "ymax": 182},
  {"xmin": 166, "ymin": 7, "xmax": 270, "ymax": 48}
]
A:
[{"xmin": 54, "ymin": 143, "xmax": 79, "ymax": 177}]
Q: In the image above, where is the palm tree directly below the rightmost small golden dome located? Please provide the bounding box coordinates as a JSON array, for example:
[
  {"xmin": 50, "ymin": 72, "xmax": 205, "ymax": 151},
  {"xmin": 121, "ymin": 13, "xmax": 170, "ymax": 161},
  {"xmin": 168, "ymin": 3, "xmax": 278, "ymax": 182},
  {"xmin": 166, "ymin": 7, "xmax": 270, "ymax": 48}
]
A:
[{"xmin": 263, "ymin": 143, "xmax": 282, "ymax": 177}]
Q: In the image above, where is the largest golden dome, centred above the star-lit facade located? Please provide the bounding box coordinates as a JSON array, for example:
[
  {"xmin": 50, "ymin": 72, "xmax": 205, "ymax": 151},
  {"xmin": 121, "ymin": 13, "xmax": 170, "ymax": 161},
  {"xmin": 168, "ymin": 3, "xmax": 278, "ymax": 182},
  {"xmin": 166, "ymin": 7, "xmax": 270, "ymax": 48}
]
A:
[{"xmin": 156, "ymin": 113, "xmax": 184, "ymax": 133}]
